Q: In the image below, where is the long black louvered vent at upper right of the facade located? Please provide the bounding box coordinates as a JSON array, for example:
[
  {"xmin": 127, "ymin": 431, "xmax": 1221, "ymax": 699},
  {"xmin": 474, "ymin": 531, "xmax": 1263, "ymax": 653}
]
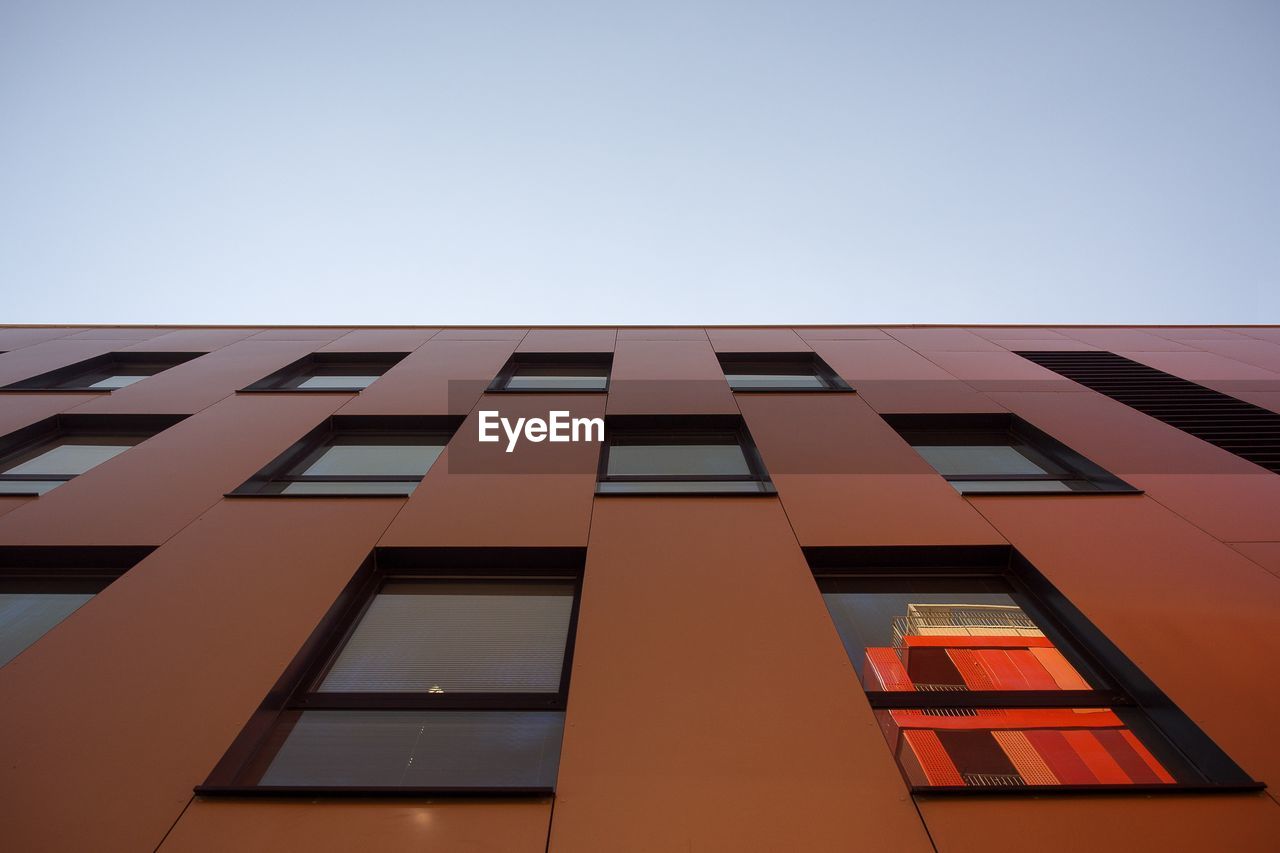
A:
[{"xmin": 1018, "ymin": 351, "xmax": 1280, "ymax": 474}]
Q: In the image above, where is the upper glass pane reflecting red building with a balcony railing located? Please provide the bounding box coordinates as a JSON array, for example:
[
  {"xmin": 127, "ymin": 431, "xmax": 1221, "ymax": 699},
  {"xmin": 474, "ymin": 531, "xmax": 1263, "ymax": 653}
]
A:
[{"xmin": 823, "ymin": 579, "xmax": 1097, "ymax": 692}]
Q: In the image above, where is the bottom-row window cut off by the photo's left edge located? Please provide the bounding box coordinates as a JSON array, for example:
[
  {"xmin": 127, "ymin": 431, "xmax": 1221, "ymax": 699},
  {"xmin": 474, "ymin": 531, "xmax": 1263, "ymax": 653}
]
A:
[{"xmin": 0, "ymin": 547, "xmax": 151, "ymax": 666}]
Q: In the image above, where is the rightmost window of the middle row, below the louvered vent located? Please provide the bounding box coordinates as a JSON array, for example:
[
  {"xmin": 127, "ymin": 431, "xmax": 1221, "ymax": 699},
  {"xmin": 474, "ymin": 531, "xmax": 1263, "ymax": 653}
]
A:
[{"xmin": 884, "ymin": 414, "xmax": 1138, "ymax": 494}]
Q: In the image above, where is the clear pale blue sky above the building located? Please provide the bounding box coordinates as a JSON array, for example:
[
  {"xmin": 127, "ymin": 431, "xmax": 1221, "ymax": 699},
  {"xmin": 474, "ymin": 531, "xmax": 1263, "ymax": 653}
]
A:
[{"xmin": 0, "ymin": 0, "xmax": 1280, "ymax": 325}]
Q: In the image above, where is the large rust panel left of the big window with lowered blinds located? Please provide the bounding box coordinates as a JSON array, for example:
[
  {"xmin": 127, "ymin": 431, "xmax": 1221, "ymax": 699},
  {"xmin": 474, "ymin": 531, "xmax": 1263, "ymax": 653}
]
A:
[{"xmin": 0, "ymin": 500, "xmax": 399, "ymax": 853}]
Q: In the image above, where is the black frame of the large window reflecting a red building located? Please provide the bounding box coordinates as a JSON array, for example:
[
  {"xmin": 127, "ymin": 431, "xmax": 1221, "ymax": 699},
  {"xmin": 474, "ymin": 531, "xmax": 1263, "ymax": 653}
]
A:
[{"xmin": 803, "ymin": 546, "xmax": 1266, "ymax": 797}]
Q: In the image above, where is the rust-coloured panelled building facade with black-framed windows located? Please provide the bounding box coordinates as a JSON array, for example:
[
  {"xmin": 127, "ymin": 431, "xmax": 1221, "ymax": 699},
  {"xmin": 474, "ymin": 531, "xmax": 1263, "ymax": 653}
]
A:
[{"xmin": 0, "ymin": 327, "xmax": 1280, "ymax": 853}]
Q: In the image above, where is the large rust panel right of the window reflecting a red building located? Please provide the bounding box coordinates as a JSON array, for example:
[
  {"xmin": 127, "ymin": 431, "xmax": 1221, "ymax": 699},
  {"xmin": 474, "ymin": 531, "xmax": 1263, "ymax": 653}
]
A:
[{"xmin": 973, "ymin": 496, "xmax": 1280, "ymax": 780}]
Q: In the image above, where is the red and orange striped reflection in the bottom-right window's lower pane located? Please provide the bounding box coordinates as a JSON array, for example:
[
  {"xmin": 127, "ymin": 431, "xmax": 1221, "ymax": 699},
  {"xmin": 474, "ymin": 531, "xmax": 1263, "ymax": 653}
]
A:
[{"xmin": 877, "ymin": 708, "xmax": 1175, "ymax": 788}]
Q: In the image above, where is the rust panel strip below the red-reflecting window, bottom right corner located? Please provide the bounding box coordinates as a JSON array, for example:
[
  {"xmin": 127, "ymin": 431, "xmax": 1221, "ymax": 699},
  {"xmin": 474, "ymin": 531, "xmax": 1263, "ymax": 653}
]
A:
[{"xmin": 918, "ymin": 794, "xmax": 1280, "ymax": 853}]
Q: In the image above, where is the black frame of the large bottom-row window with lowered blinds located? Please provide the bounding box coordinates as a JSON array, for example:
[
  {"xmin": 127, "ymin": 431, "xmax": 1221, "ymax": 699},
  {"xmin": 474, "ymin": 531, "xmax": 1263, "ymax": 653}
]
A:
[{"xmin": 195, "ymin": 547, "xmax": 586, "ymax": 798}]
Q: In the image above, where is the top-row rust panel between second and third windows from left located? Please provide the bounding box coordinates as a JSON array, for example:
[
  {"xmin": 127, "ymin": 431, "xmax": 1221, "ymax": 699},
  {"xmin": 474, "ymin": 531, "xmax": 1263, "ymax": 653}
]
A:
[{"xmin": 342, "ymin": 340, "xmax": 516, "ymax": 415}]
